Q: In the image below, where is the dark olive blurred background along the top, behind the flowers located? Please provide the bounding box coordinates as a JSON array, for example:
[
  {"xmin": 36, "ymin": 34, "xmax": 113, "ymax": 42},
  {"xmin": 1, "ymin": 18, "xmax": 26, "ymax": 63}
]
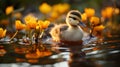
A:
[{"xmin": 0, "ymin": 0, "xmax": 120, "ymax": 32}]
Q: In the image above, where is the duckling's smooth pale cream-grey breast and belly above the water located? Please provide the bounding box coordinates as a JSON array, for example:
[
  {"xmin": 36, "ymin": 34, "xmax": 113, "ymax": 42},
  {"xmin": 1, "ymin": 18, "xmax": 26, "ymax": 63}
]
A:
[{"xmin": 61, "ymin": 27, "xmax": 83, "ymax": 41}]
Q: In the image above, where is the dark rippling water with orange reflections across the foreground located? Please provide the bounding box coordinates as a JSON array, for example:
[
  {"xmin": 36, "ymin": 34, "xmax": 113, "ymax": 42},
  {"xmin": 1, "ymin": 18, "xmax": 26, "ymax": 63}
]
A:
[{"xmin": 0, "ymin": 36, "xmax": 120, "ymax": 67}]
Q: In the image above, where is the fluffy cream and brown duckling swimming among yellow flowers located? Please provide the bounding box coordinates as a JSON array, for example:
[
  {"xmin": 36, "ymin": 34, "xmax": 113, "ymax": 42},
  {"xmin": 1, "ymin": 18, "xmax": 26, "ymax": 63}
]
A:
[{"xmin": 50, "ymin": 10, "xmax": 83, "ymax": 44}]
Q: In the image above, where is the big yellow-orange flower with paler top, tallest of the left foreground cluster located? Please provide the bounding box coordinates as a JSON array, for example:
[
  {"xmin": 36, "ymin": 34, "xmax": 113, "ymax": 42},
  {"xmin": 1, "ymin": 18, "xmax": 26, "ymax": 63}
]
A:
[{"xmin": 24, "ymin": 15, "xmax": 37, "ymax": 29}]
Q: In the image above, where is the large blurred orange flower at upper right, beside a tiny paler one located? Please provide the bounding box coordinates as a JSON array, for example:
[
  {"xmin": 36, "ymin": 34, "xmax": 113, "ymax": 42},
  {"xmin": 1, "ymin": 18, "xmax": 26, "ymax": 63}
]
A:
[{"xmin": 101, "ymin": 7, "xmax": 114, "ymax": 18}]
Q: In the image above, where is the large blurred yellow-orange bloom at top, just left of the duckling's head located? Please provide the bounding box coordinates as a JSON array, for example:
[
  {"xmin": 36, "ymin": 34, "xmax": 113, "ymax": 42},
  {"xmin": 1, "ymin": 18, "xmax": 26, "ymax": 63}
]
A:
[{"xmin": 47, "ymin": 3, "xmax": 70, "ymax": 21}]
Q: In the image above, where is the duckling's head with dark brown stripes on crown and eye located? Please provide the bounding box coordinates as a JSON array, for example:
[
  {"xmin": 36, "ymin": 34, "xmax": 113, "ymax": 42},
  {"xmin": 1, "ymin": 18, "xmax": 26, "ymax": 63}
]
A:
[{"xmin": 66, "ymin": 10, "xmax": 81, "ymax": 27}]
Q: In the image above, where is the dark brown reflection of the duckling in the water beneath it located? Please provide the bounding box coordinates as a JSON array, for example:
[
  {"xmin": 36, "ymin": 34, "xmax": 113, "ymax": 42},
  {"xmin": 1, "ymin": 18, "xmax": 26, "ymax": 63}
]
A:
[{"xmin": 68, "ymin": 45, "xmax": 88, "ymax": 67}]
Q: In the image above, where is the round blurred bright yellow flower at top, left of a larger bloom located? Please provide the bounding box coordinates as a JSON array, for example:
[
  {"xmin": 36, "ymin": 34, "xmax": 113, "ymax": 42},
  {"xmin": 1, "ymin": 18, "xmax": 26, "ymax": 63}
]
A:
[{"xmin": 39, "ymin": 3, "xmax": 52, "ymax": 14}]
